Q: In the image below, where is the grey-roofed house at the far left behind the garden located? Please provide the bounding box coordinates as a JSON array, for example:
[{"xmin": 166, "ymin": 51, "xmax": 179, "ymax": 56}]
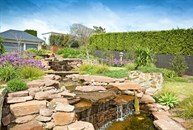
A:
[{"xmin": 0, "ymin": 29, "xmax": 44, "ymax": 51}]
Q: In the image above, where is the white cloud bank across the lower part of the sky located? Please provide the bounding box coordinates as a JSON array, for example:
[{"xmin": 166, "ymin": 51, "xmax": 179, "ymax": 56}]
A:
[{"xmin": 1, "ymin": 2, "xmax": 193, "ymax": 38}]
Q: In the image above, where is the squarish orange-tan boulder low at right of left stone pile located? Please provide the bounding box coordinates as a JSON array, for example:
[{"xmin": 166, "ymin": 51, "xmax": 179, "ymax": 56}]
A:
[{"xmin": 53, "ymin": 112, "xmax": 75, "ymax": 126}]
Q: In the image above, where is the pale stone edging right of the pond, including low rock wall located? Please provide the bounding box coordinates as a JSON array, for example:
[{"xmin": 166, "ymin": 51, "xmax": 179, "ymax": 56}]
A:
[{"xmin": 68, "ymin": 74, "xmax": 185, "ymax": 130}]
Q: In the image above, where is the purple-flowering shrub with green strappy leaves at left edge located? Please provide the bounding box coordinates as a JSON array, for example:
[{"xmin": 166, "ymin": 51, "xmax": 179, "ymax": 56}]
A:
[{"xmin": 0, "ymin": 53, "xmax": 44, "ymax": 81}]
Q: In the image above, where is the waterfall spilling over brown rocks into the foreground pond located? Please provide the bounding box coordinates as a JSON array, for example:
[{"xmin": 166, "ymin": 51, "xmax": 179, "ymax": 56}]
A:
[{"xmin": 59, "ymin": 77, "xmax": 156, "ymax": 130}]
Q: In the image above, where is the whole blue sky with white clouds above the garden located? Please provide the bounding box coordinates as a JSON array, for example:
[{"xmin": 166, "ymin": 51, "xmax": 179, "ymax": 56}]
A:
[{"xmin": 0, "ymin": 0, "xmax": 193, "ymax": 37}]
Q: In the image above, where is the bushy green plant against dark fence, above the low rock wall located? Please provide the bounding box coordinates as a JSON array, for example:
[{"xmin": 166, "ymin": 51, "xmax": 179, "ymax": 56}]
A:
[{"xmin": 135, "ymin": 48, "xmax": 154, "ymax": 69}]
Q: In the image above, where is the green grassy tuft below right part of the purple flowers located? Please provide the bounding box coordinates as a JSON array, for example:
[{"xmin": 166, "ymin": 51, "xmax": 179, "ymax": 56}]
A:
[{"xmin": 19, "ymin": 66, "xmax": 44, "ymax": 79}]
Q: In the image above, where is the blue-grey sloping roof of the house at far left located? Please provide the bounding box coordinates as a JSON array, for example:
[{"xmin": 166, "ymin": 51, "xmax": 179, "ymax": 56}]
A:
[{"xmin": 0, "ymin": 29, "xmax": 44, "ymax": 42}]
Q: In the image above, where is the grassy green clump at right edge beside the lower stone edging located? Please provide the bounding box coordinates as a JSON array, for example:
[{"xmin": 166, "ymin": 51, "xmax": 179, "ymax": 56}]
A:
[{"xmin": 178, "ymin": 95, "xmax": 193, "ymax": 119}]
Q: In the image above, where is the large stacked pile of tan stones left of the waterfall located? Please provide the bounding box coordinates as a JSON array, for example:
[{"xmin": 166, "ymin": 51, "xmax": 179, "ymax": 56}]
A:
[{"xmin": 2, "ymin": 75, "xmax": 94, "ymax": 130}]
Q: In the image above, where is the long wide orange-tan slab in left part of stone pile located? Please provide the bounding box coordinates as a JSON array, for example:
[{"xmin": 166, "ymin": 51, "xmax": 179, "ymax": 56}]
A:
[{"xmin": 10, "ymin": 100, "xmax": 46, "ymax": 117}]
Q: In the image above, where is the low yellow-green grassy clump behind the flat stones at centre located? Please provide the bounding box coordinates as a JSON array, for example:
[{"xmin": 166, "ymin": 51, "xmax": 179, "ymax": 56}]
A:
[{"xmin": 79, "ymin": 64, "xmax": 109, "ymax": 74}]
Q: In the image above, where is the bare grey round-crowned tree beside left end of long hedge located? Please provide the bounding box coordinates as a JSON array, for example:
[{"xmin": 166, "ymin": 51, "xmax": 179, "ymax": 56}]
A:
[{"xmin": 70, "ymin": 24, "xmax": 94, "ymax": 45}]
